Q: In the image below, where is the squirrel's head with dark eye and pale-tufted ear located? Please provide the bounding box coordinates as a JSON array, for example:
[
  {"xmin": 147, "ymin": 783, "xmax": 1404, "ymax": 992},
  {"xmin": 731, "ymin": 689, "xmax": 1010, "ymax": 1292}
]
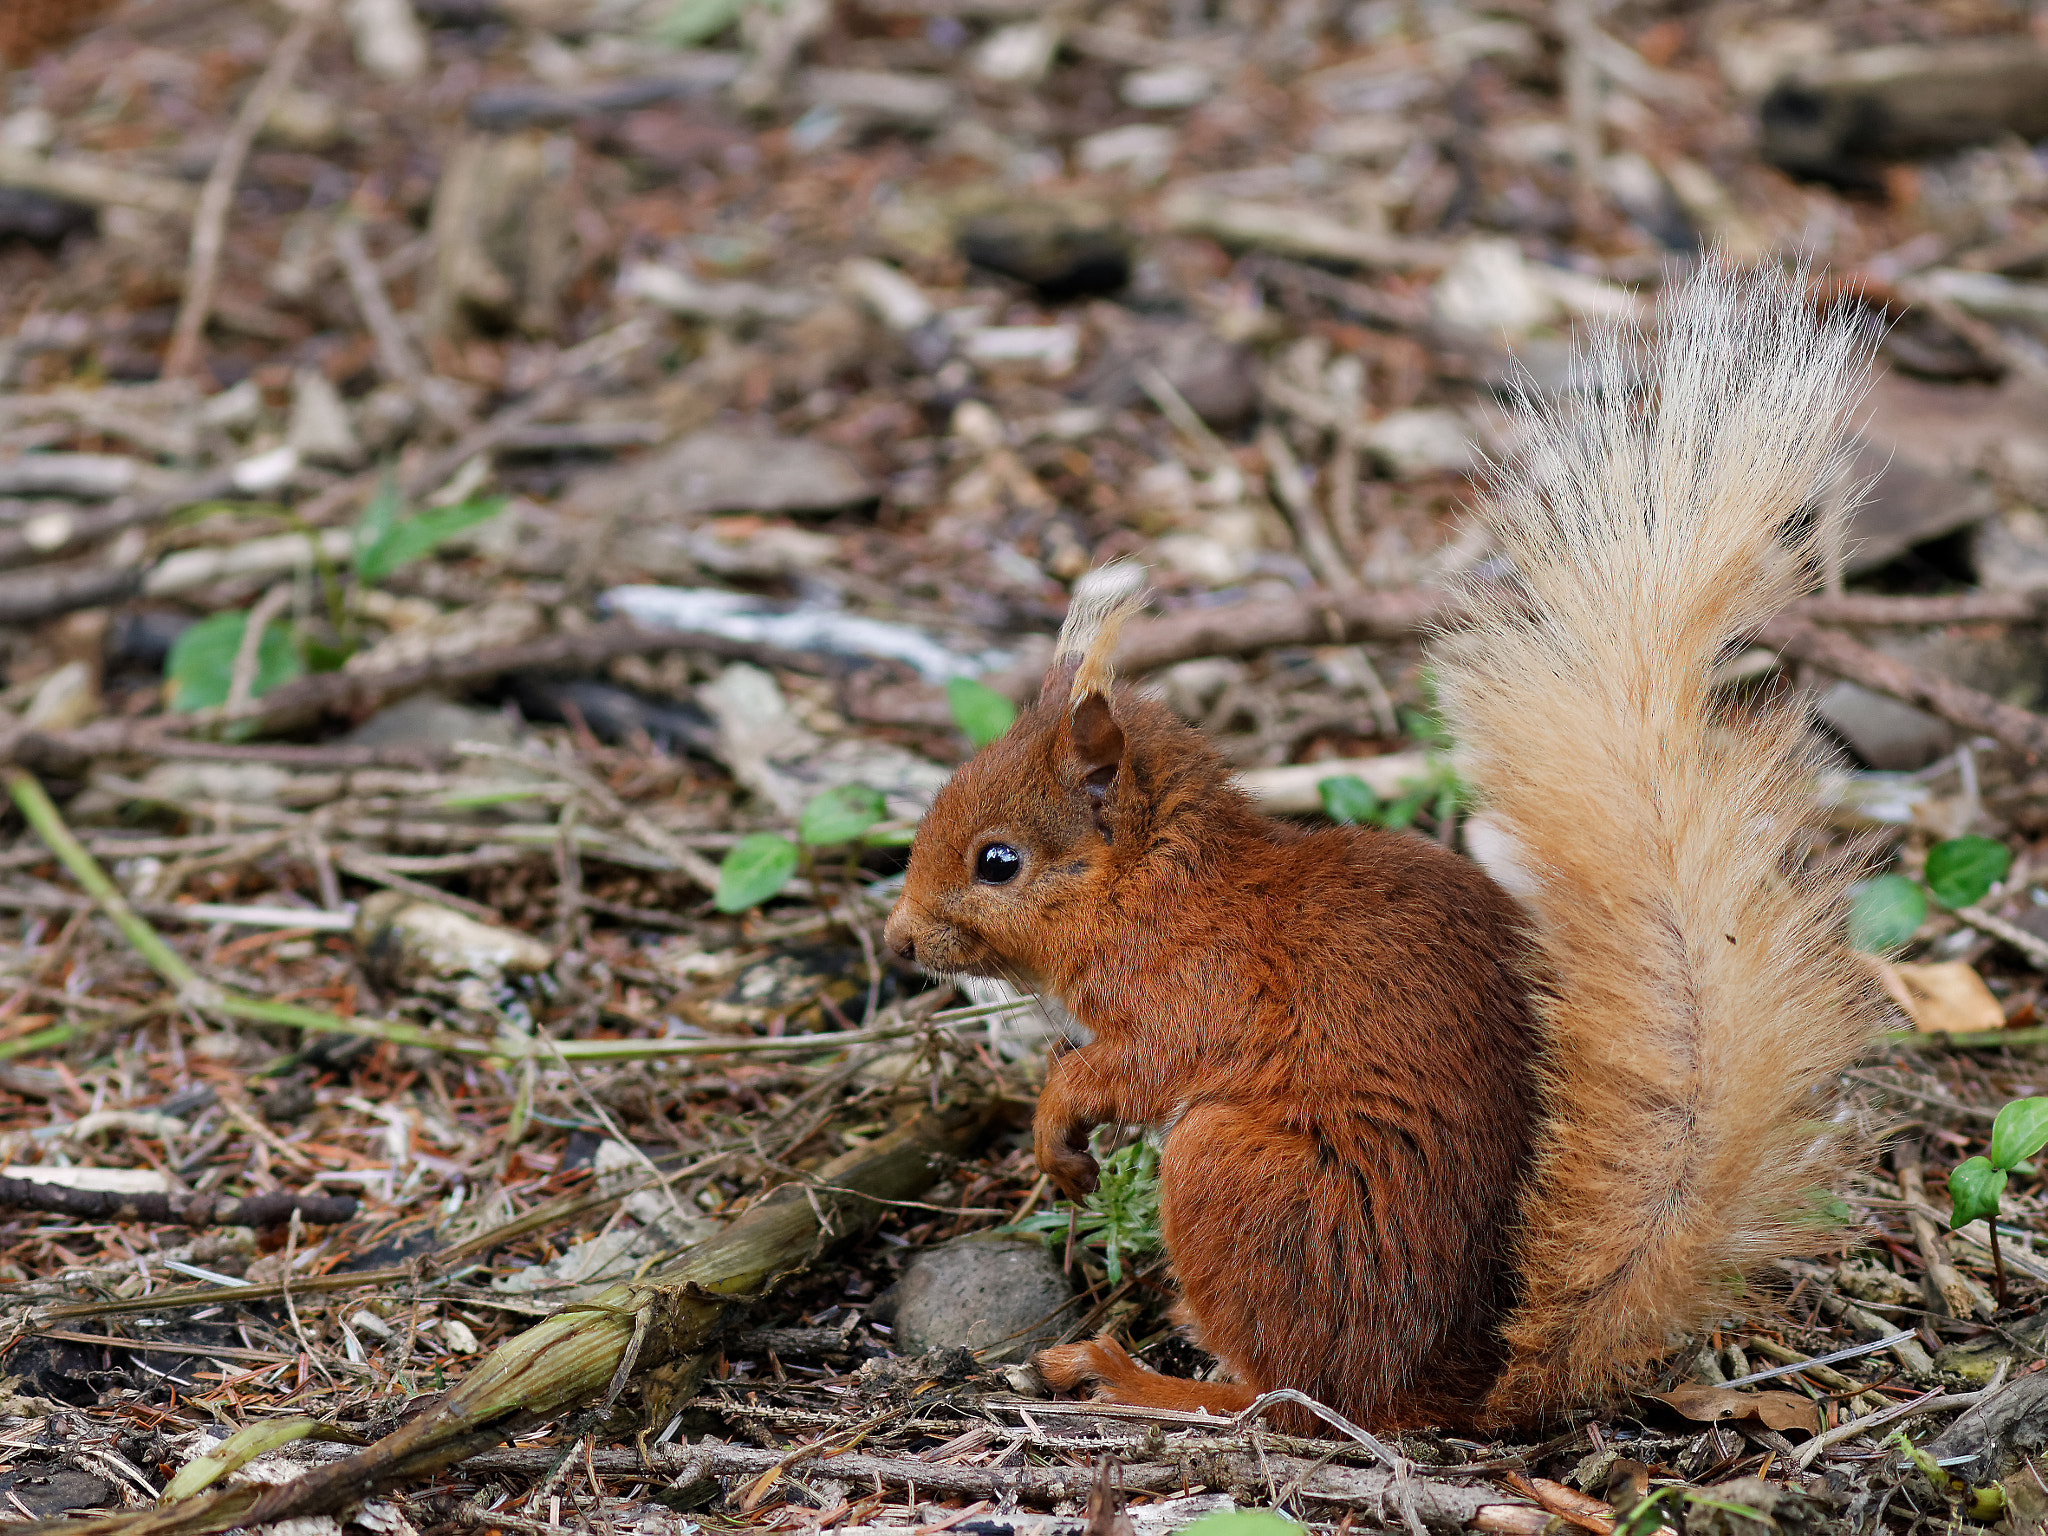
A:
[{"xmin": 887, "ymin": 561, "xmax": 1204, "ymax": 989}]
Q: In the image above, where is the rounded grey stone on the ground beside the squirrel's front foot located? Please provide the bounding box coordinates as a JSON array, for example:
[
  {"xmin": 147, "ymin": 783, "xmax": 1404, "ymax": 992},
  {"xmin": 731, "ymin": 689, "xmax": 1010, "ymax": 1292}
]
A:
[{"xmin": 876, "ymin": 1233, "xmax": 1073, "ymax": 1360}]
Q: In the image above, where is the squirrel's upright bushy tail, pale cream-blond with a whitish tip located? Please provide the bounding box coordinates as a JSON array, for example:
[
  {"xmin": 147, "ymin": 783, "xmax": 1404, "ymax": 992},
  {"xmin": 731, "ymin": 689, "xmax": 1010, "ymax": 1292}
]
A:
[{"xmin": 1440, "ymin": 264, "xmax": 1872, "ymax": 1421}]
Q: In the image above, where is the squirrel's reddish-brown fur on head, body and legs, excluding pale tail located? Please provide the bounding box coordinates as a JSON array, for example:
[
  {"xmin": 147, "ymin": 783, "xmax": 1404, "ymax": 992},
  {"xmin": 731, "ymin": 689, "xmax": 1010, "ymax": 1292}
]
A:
[{"xmin": 889, "ymin": 679, "xmax": 1536, "ymax": 1425}]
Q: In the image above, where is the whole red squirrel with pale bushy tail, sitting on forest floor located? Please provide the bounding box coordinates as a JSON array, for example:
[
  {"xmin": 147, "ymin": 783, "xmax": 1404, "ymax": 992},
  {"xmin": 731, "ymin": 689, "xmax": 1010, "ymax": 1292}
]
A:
[{"xmin": 887, "ymin": 264, "xmax": 1874, "ymax": 1430}]
